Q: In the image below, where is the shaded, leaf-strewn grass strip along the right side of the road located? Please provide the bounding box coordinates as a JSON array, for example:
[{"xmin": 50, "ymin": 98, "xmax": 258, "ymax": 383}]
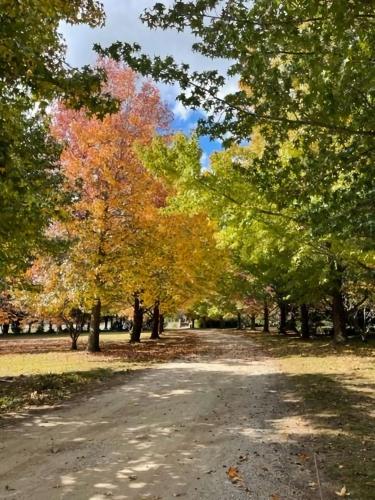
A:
[{"xmin": 250, "ymin": 333, "xmax": 375, "ymax": 500}]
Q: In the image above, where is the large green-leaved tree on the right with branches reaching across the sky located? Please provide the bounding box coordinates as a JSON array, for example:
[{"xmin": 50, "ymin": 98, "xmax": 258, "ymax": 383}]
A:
[{"xmin": 98, "ymin": 0, "xmax": 375, "ymax": 340}]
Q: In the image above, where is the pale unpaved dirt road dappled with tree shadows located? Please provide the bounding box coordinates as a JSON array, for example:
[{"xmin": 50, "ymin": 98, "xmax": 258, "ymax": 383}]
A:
[{"xmin": 0, "ymin": 331, "xmax": 329, "ymax": 500}]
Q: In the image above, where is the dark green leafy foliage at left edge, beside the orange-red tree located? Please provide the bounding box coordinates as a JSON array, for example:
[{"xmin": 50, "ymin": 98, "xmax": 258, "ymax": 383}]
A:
[{"xmin": 0, "ymin": 0, "xmax": 116, "ymax": 287}]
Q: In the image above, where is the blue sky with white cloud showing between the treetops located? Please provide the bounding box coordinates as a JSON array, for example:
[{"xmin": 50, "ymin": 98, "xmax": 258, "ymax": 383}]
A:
[{"xmin": 61, "ymin": 0, "xmax": 236, "ymax": 167}]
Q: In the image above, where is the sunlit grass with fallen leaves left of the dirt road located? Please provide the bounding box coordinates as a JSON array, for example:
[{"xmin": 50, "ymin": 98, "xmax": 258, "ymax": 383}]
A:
[{"xmin": 0, "ymin": 331, "xmax": 210, "ymax": 418}]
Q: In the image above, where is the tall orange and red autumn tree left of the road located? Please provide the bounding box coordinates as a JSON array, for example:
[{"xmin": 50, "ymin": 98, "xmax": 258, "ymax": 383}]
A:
[{"xmin": 53, "ymin": 60, "xmax": 169, "ymax": 351}]
